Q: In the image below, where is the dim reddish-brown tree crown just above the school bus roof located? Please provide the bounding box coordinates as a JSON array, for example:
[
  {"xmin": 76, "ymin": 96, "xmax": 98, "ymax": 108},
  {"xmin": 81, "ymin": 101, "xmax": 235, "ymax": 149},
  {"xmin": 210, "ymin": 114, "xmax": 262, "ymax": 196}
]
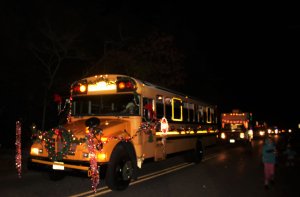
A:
[{"xmin": 89, "ymin": 31, "xmax": 186, "ymax": 88}]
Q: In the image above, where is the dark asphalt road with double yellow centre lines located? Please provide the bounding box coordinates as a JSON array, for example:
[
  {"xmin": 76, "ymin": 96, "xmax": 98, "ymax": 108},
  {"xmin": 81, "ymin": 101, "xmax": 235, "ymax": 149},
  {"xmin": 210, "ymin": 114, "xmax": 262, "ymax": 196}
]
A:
[{"xmin": 0, "ymin": 135, "xmax": 300, "ymax": 197}]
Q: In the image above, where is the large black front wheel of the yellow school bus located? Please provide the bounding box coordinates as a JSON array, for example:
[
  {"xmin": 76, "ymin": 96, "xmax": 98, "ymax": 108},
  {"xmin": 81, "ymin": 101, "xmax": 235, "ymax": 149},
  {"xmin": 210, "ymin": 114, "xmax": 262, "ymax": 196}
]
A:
[{"xmin": 105, "ymin": 145, "xmax": 133, "ymax": 191}]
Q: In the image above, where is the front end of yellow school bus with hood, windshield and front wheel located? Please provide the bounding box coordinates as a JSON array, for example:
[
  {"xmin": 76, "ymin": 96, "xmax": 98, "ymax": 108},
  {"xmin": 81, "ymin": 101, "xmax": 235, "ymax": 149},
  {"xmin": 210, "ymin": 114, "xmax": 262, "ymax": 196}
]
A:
[{"xmin": 30, "ymin": 75, "xmax": 141, "ymax": 190}]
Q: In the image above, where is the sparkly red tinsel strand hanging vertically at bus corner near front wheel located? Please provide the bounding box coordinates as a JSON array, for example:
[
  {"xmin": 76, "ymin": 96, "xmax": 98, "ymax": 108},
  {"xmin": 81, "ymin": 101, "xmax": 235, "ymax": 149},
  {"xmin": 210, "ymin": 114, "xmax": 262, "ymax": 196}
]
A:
[{"xmin": 87, "ymin": 128, "xmax": 99, "ymax": 193}]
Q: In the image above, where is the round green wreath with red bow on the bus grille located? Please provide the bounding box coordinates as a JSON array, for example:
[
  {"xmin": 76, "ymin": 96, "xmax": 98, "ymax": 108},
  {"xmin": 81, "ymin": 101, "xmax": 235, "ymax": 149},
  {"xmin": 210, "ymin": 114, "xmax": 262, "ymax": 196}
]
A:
[{"xmin": 43, "ymin": 127, "xmax": 72, "ymax": 161}]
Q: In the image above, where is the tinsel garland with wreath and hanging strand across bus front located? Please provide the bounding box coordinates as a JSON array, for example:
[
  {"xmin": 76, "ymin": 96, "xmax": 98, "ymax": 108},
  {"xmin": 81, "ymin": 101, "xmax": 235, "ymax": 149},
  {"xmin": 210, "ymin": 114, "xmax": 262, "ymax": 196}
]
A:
[{"xmin": 31, "ymin": 118, "xmax": 160, "ymax": 192}]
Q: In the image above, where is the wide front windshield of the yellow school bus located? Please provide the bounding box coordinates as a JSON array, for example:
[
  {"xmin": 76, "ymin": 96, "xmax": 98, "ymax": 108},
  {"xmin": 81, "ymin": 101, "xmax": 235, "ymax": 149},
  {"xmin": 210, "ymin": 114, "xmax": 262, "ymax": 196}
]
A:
[{"xmin": 72, "ymin": 94, "xmax": 140, "ymax": 116}]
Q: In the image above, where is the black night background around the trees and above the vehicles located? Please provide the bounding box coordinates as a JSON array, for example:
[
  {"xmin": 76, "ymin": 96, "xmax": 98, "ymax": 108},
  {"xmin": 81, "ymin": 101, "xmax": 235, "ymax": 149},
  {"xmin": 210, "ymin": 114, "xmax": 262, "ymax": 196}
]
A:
[{"xmin": 0, "ymin": 0, "xmax": 300, "ymax": 148}]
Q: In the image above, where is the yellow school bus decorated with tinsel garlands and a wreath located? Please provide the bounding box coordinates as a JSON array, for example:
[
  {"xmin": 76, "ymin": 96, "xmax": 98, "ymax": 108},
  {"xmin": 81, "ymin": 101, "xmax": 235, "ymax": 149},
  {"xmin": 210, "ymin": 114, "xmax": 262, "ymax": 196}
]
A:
[{"xmin": 30, "ymin": 74, "xmax": 218, "ymax": 190}]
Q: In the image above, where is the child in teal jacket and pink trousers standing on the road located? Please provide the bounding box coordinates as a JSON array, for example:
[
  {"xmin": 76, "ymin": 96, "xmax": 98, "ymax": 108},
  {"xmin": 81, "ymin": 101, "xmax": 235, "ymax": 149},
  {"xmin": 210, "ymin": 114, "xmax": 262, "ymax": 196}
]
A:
[{"xmin": 262, "ymin": 137, "xmax": 276, "ymax": 189}]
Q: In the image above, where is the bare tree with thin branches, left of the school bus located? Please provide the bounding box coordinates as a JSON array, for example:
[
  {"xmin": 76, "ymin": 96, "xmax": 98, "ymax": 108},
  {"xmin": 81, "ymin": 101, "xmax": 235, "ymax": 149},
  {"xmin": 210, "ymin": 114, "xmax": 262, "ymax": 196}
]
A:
[{"xmin": 30, "ymin": 22, "xmax": 86, "ymax": 129}]
